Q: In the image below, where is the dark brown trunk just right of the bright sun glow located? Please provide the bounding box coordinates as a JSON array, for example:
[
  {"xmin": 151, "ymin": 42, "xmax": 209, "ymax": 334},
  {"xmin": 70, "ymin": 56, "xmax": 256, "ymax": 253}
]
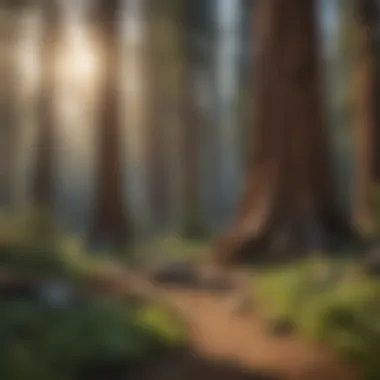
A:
[{"xmin": 90, "ymin": 0, "xmax": 131, "ymax": 249}]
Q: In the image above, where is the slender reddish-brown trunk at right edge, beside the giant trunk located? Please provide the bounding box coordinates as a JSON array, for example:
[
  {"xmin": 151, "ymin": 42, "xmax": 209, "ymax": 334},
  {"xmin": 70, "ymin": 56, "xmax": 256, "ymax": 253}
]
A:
[{"xmin": 352, "ymin": 0, "xmax": 377, "ymax": 232}]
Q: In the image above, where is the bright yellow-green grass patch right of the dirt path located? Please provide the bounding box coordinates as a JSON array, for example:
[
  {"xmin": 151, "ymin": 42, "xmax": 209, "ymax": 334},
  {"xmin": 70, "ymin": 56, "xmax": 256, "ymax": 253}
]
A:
[{"xmin": 255, "ymin": 260, "xmax": 380, "ymax": 379}]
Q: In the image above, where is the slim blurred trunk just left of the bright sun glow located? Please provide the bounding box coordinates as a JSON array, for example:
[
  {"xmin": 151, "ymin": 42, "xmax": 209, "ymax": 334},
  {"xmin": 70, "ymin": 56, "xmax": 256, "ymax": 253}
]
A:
[{"xmin": 33, "ymin": 1, "xmax": 60, "ymax": 209}]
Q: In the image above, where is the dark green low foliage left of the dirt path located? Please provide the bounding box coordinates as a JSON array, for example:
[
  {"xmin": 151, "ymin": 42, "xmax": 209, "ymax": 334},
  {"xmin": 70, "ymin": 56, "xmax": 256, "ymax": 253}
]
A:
[{"xmin": 0, "ymin": 301, "xmax": 185, "ymax": 380}]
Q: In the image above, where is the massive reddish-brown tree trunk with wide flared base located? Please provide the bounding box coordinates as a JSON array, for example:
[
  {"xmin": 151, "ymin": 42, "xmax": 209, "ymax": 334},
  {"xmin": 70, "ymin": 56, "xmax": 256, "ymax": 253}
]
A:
[{"xmin": 215, "ymin": 0, "xmax": 353, "ymax": 264}]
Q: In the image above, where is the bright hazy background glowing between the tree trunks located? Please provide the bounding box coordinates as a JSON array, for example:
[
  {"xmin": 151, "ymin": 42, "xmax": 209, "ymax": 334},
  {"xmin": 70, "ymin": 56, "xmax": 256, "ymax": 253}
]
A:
[{"xmin": 1, "ymin": 0, "xmax": 353, "ymax": 235}]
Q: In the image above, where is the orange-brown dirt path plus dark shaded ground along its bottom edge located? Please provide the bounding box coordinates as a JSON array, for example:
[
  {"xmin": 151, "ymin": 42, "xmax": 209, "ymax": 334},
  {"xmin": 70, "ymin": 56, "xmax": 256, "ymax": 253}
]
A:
[{"xmin": 116, "ymin": 268, "xmax": 361, "ymax": 380}]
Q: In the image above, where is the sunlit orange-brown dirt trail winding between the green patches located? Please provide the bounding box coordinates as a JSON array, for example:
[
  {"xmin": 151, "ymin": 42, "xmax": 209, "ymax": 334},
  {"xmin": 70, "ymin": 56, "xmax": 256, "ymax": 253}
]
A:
[{"xmin": 124, "ymin": 270, "xmax": 361, "ymax": 380}]
